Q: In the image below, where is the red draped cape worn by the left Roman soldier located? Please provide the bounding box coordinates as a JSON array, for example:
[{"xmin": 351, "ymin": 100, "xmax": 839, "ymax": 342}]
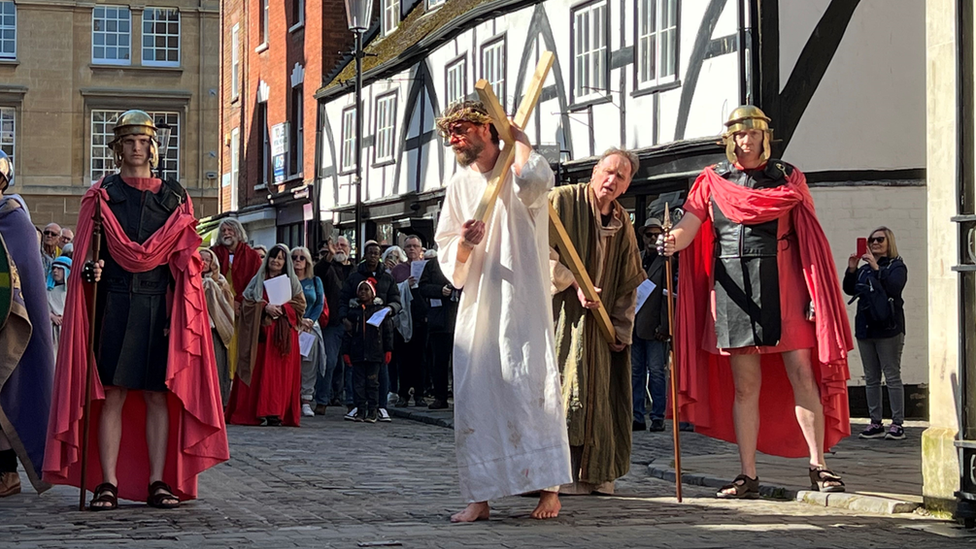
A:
[{"xmin": 44, "ymin": 181, "xmax": 230, "ymax": 500}]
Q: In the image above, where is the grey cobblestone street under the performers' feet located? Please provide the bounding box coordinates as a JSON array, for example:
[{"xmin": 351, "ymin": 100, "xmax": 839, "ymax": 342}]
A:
[{"xmin": 0, "ymin": 414, "xmax": 976, "ymax": 549}]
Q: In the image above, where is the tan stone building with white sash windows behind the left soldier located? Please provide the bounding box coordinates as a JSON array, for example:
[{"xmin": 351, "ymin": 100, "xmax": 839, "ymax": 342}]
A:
[{"xmin": 0, "ymin": 0, "xmax": 220, "ymax": 227}]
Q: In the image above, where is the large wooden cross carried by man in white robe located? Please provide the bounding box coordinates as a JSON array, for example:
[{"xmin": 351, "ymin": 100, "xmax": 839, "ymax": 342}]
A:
[{"xmin": 474, "ymin": 51, "xmax": 617, "ymax": 344}]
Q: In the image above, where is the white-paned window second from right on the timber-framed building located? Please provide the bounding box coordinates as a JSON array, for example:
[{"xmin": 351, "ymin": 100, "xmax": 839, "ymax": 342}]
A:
[{"xmin": 572, "ymin": 2, "xmax": 609, "ymax": 101}]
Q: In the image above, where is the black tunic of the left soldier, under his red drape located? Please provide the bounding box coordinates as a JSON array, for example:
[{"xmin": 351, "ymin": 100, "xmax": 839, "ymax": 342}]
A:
[{"xmin": 95, "ymin": 174, "xmax": 186, "ymax": 391}]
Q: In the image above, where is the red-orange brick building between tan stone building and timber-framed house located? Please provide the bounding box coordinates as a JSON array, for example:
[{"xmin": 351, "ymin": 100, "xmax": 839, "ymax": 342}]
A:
[{"xmin": 220, "ymin": 0, "xmax": 352, "ymax": 246}]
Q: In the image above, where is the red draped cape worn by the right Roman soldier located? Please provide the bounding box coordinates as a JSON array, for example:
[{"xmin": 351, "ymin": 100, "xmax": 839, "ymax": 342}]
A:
[{"xmin": 675, "ymin": 168, "xmax": 854, "ymax": 457}]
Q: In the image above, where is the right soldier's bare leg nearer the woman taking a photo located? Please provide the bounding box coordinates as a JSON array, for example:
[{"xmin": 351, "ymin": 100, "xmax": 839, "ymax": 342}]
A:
[{"xmin": 783, "ymin": 349, "xmax": 826, "ymax": 467}]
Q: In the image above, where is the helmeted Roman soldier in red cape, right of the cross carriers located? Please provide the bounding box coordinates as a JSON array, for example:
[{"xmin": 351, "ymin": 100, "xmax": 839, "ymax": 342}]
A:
[{"xmin": 659, "ymin": 106, "xmax": 853, "ymax": 498}]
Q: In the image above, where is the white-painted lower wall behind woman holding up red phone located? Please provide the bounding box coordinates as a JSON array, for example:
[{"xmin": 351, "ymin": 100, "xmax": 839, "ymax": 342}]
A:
[{"xmin": 811, "ymin": 187, "xmax": 929, "ymax": 385}]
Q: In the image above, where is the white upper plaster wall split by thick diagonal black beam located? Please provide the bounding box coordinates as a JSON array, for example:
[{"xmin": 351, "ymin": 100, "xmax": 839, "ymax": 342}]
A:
[{"xmin": 773, "ymin": 0, "xmax": 926, "ymax": 171}]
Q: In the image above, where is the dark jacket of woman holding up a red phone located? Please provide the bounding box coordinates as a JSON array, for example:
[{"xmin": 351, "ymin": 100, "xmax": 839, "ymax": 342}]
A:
[{"xmin": 844, "ymin": 257, "xmax": 908, "ymax": 339}]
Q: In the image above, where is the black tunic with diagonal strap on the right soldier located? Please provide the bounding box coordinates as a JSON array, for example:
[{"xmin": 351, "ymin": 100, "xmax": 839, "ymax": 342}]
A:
[{"xmin": 712, "ymin": 161, "xmax": 792, "ymax": 349}]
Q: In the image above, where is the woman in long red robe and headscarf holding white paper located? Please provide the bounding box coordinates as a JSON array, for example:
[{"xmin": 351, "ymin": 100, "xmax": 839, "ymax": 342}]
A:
[{"xmin": 227, "ymin": 244, "xmax": 305, "ymax": 427}]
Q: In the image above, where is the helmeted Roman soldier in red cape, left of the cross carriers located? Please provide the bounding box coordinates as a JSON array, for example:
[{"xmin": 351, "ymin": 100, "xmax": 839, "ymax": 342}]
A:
[{"xmin": 43, "ymin": 111, "xmax": 230, "ymax": 511}]
